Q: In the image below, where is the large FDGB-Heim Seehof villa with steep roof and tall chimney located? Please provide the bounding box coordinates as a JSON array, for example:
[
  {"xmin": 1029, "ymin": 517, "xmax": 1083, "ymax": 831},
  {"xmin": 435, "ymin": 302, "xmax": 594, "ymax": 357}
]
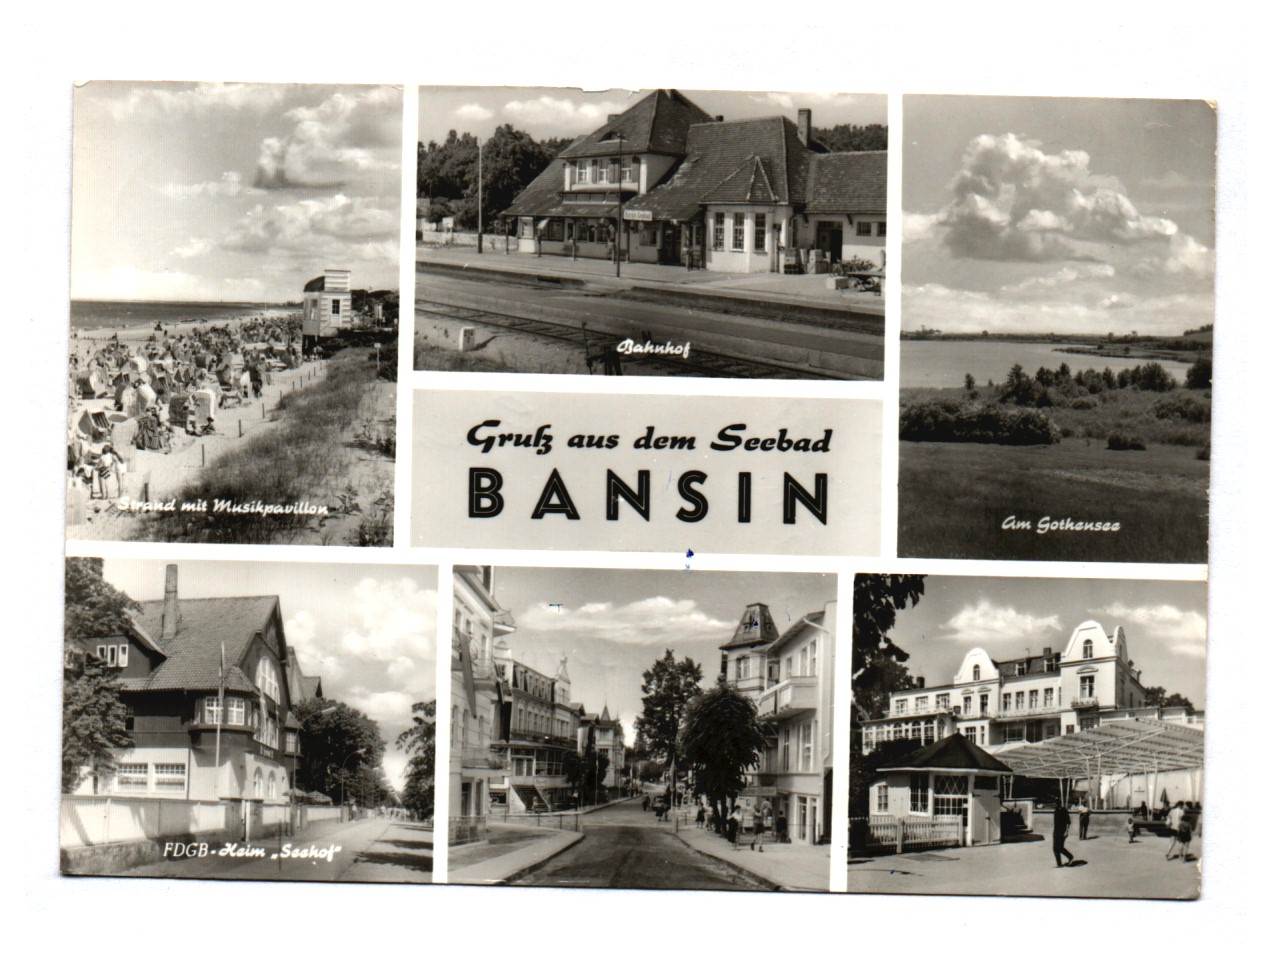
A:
[{"xmin": 75, "ymin": 565, "xmax": 305, "ymax": 804}]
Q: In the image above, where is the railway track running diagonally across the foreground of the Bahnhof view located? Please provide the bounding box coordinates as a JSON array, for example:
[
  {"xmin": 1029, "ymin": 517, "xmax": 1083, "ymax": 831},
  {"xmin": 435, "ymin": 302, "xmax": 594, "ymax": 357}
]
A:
[{"xmin": 414, "ymin": 299, "xmax": 833, "ymax": 380}]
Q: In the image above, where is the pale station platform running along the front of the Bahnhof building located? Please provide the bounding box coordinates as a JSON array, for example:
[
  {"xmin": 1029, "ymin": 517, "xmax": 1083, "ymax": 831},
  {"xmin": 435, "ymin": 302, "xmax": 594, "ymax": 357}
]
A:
[{"xmin": 416, "ymin": 245, "xmax": 883, "ymax": 315}]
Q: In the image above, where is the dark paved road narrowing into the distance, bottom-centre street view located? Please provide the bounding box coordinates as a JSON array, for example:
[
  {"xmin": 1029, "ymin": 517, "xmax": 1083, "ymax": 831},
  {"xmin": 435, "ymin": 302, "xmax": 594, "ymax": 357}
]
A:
[{"xmin": 508, "ymin": 801, "xmax": 765, "ymax": 891}]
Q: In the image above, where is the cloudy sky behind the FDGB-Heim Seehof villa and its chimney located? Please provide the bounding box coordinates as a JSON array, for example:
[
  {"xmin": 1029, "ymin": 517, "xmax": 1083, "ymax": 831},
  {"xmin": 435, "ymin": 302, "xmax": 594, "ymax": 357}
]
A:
[{"xmin": 103, "ymin": 560, "xmax": 437, "ymax": 790}]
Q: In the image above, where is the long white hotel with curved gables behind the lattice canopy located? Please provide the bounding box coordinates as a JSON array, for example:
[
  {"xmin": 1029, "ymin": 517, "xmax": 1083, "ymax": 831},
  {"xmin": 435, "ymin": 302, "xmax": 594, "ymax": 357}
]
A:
[{"xmin": 860, "ymin": 619, "xmax": 1202, "ymax": 753}]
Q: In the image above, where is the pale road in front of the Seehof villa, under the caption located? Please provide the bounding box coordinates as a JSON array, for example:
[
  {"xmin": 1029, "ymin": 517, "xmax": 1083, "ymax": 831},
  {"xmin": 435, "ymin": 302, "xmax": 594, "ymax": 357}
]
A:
[{"xmin": 119, "ymin": 818, "xmax": 432, "ymax": 881}]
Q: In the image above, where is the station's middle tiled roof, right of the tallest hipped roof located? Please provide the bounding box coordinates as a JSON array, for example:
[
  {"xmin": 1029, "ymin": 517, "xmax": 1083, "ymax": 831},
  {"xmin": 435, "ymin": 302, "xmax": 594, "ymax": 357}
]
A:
[{"xmin": 629, "ymin": 117, "xmax": 812, "ymax": 221}]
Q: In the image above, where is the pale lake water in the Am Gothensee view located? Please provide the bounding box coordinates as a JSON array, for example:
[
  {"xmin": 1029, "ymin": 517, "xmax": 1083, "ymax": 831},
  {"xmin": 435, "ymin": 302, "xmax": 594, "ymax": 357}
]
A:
[{"xmin": 900, "ymin": 340, "xmax": 1190, "ymax": 388}]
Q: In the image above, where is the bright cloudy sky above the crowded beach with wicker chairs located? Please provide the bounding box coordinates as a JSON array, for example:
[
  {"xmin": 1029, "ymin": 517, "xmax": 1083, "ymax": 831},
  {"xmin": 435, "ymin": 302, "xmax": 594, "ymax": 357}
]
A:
[{"xmin": 71, "ymin": 81, "xmax": 402, "ymax": 301}]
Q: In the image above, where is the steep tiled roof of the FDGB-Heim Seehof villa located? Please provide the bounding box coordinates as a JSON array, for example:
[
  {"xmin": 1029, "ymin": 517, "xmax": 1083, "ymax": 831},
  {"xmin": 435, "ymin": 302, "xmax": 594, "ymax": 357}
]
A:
[{"xmin": 125, "ymin": 595, "xmax": 278, "ymax": 692}]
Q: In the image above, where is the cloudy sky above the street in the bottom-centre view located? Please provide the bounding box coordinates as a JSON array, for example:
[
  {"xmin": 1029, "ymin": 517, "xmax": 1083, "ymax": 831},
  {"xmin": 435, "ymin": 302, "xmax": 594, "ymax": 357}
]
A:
[{"xmin": 482, "ymin": 568, "xmax": 838, "ymax": 746}]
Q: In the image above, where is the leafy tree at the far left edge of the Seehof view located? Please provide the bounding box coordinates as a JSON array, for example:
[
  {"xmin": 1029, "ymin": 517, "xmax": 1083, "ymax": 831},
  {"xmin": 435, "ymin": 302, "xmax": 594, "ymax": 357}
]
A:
[{"xmin": 62, "ymin": 558, "xmax": 141, "ymax": 794}]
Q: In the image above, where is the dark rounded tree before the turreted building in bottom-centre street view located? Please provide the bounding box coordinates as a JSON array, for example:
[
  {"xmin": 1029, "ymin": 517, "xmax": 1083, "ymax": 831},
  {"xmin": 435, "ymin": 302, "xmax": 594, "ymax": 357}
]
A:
[{"xmin": 683, "ymin": 683, "xmax": 764, "ymax": 818}]
